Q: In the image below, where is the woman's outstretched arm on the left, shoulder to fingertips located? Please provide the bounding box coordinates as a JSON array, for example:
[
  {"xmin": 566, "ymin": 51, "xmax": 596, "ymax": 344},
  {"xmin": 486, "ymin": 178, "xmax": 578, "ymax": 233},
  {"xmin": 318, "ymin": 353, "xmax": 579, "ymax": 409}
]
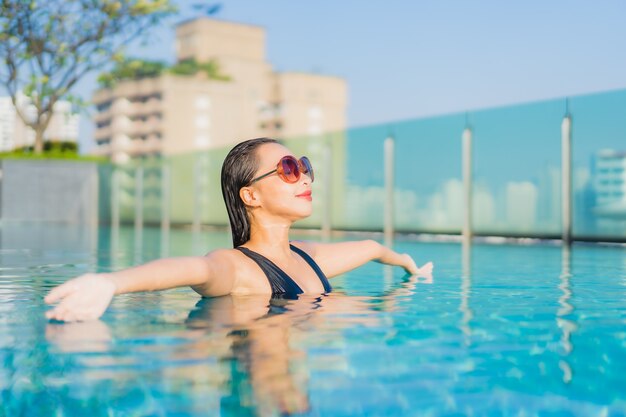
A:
[{"xmin": 45, "ymin": 251, "xmax": 235, "ymax": 321}]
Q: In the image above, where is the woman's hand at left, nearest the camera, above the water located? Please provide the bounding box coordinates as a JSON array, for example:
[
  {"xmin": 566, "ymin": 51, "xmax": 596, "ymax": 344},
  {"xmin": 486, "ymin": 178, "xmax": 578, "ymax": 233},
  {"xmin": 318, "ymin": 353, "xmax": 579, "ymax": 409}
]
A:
[{"xmin": 44, "ymin": 274, "xmax": 116, "ymax": 321}]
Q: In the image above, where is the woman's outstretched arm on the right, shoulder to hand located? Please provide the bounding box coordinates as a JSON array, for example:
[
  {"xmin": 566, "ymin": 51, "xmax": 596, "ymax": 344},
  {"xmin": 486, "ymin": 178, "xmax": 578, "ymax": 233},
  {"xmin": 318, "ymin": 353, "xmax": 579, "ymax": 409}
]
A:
[{"xmin": 294, "ymin": 240, "xmax": 433, "ymax": 278}]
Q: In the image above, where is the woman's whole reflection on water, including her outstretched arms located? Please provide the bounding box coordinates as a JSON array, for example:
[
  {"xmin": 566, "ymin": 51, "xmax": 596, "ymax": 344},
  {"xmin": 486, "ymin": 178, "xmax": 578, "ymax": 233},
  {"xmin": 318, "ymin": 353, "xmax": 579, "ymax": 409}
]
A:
[{"xmin": 45, "ymin": 294, "xmax": 388, "ymax": 416}]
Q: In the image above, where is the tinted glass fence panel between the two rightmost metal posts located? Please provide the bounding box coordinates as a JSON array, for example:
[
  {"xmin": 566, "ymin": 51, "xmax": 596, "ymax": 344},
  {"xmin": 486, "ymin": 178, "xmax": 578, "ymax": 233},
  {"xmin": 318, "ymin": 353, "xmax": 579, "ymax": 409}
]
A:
[{"xmin": 469, "ymin": 100, "xmax": 565, "ymax": 236}]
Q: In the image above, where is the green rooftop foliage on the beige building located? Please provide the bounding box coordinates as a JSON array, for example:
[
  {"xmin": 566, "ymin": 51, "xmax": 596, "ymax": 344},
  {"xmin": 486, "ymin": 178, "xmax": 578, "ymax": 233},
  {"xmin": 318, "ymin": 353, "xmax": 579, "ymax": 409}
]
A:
[{"xmin": 98, "ymin": 58, "xmax": 231, "ymax": 88}]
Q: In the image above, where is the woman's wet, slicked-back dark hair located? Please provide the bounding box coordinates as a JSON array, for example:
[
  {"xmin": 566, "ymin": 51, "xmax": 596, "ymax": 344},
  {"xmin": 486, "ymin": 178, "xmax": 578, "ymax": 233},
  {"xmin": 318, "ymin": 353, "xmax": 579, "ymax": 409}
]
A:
[{"xmin": 222, "ymin": 138, "xmax": 279, "ymax": 248}]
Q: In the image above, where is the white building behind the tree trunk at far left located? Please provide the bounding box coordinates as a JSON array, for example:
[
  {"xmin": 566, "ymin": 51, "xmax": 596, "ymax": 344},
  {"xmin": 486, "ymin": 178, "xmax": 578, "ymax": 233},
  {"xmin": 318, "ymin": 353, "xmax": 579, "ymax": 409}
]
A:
[{"xmin": 0, "ymin": 94, "xmax": 80, "ymax": 152}]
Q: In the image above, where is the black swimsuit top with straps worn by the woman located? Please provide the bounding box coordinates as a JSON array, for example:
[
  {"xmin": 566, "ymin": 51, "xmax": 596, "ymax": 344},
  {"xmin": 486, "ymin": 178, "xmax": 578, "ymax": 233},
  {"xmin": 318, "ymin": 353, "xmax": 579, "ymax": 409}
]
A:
[{"xmin": 235, "ymin": 244, "xmax": 332, "ymax": 298}]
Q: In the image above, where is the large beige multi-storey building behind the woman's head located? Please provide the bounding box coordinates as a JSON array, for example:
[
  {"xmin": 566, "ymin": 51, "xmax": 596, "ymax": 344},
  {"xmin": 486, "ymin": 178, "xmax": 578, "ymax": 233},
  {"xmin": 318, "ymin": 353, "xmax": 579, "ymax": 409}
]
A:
[{"xmin": 93, "ymin": 18, "xmax": 347, "ymax": 163}]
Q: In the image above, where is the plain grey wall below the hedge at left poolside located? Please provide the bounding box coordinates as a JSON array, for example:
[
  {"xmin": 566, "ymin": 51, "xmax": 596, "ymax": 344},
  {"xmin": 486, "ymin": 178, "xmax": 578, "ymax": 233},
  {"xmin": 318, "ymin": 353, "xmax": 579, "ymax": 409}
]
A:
[{"xmin": 0, "ymin": 160, "xmax": 98, "ymax": 223}]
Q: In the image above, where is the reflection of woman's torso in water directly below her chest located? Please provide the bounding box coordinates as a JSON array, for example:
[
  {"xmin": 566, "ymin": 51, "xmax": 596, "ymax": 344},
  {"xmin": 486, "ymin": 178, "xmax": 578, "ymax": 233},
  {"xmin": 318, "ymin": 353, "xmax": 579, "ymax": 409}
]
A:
[{"xmin": 187, "ymin": 296, "xmax": 330, "ymax": 415}]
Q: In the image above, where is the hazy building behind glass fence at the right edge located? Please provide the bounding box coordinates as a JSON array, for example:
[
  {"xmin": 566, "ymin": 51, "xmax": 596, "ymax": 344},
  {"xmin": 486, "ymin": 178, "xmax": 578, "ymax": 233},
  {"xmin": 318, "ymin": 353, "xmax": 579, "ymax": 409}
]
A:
[{"xmin": 593, "ymin": 149, "xmax": 626, "ymax": 217}]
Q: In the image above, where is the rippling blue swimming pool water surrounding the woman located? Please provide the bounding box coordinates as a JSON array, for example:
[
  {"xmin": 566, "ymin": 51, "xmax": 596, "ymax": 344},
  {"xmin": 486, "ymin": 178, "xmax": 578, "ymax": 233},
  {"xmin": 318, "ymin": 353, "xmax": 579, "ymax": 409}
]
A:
[{"xmin": 0, "ymin": 225, "xmax": 626, "ymax": 417}]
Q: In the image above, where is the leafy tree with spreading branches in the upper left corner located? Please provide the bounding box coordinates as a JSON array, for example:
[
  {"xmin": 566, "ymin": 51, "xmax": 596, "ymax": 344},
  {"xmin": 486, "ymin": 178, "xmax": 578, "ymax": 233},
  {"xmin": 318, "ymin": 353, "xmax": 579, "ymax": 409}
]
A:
[{"xmin": 0, "ymin": 0, "xmax": 175, "ymax": 153}]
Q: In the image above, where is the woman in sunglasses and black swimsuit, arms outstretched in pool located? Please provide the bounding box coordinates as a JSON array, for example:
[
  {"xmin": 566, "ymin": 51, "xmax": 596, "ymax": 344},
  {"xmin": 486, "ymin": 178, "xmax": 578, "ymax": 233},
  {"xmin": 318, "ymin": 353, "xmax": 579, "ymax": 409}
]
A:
[{"xmin": 45, "ymin": 138, "xmax": 432, "ymax": 321}]
